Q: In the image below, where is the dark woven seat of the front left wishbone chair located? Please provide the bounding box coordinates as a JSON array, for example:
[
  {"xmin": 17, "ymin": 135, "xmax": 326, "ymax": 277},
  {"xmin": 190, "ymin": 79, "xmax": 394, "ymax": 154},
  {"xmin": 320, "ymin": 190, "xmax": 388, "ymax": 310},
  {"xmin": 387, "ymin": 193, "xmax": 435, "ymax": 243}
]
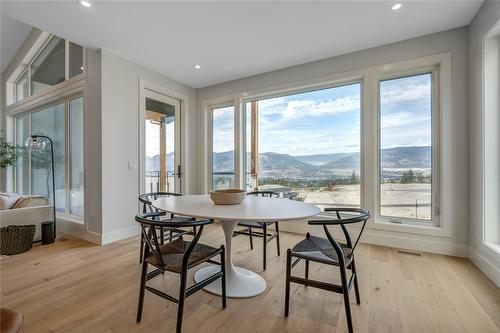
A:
[{"xmin": 145, "ymin": 238, "xmax": 221, "ymax": 273}]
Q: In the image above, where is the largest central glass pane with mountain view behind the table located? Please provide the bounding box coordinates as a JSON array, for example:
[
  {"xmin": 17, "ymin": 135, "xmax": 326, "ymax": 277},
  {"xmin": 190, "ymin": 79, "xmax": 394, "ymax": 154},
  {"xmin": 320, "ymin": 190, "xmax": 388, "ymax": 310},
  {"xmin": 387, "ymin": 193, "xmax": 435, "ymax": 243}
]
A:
[{"xmin": 245, "ymin": 83, "xmax": 361, "ymax": 208}]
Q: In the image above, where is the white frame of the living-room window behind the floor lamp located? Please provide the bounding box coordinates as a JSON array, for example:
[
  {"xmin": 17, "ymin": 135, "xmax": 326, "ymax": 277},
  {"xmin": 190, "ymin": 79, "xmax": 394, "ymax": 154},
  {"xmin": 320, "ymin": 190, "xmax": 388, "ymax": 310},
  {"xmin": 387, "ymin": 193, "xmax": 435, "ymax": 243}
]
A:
[{"xmin": 13, "ymin": 91, "xmax": 86, "ymax": 220}]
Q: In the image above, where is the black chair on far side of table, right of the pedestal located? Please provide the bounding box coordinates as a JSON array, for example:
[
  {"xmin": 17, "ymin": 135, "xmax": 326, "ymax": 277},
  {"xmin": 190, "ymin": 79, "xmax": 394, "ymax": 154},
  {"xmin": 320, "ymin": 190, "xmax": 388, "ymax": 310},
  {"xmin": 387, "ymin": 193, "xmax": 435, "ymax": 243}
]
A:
[{"xmin": 233, "ymin": 191, "xmax": 280, "ymax": 270}]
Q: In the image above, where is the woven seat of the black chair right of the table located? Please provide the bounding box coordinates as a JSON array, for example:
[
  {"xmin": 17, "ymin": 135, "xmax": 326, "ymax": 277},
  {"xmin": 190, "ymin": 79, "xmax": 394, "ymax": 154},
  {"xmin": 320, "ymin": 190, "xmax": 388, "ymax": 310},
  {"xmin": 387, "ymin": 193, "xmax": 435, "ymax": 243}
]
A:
[{"xmin": 292, "ymin": 236, "xmax": 351, "ymax": 266}]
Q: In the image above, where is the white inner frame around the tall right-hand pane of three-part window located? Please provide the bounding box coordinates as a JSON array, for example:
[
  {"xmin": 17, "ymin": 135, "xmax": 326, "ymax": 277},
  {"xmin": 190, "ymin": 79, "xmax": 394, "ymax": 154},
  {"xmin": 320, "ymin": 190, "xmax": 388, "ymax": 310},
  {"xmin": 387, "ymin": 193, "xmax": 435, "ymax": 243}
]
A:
[{"xmin": 374, "ymin": 65, "xmax": 441, "ymax": 227}]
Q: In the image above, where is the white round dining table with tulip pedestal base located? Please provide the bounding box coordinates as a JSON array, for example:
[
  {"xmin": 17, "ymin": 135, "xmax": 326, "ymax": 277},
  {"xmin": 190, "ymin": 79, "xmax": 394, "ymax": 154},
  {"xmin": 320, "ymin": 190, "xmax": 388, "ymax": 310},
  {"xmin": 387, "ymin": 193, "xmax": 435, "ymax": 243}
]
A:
[{"xmin": 152, "ymin": 194, "xmax": 320, "ymax": 298}]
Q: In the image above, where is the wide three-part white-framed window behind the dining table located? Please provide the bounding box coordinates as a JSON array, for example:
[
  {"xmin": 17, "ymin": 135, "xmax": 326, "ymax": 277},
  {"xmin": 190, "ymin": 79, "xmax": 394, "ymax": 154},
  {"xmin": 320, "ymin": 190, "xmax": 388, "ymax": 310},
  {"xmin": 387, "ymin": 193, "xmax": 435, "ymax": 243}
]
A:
[{"xmin": 203, "ymin": 53, "xmax": 450, "ymax": 231}]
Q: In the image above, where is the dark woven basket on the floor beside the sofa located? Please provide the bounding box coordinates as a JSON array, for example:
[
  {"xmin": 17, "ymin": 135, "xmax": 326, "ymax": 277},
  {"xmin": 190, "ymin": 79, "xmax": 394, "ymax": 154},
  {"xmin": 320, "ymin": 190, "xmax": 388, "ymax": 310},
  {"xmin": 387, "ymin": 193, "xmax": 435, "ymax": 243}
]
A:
[{"xmin": 0, "ymin": 225, "xmax": 36, "ymax": 255}]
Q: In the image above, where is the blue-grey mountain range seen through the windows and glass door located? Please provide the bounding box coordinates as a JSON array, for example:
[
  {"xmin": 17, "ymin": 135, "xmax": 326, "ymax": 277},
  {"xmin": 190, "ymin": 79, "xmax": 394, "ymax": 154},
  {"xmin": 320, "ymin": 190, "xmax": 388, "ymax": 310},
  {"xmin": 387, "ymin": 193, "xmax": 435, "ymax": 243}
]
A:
[{"xmin": 146, "ymin": 146, "xmax": 432, "ymax": 178}]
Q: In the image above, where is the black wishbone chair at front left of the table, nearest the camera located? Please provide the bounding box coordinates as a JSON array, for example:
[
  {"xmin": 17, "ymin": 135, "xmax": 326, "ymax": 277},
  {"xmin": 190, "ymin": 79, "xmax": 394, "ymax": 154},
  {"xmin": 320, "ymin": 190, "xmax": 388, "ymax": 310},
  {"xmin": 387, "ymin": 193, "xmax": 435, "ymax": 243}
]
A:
[{"xmin": 135, "ymin": 212, "xmax": 226, "ymax": 333}]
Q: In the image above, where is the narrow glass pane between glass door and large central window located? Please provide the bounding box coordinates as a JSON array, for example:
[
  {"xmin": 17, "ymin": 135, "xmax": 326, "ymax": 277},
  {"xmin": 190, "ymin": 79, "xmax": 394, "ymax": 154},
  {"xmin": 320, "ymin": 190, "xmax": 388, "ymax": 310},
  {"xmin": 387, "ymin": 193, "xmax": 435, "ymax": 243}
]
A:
[{"xmin": 212, "ymin": 106, "xmax": 235, "ymax": 189}]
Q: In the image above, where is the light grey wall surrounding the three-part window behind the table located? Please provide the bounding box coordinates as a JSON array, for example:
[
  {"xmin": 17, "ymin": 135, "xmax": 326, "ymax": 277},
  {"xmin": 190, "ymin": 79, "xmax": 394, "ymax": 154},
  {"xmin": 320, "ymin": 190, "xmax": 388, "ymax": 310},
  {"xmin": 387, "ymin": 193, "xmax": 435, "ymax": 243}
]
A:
[{"xmin": 196, "ymin": 27, "xmax": 468, "ymax": 256}]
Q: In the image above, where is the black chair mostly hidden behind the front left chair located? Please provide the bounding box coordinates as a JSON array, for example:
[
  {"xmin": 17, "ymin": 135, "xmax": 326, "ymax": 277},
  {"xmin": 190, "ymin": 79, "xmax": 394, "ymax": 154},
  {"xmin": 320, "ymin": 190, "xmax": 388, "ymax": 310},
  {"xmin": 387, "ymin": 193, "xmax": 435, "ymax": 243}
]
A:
[{"xmin": 139, "ymin": 192, "xmax": 196, "ymax": 263}]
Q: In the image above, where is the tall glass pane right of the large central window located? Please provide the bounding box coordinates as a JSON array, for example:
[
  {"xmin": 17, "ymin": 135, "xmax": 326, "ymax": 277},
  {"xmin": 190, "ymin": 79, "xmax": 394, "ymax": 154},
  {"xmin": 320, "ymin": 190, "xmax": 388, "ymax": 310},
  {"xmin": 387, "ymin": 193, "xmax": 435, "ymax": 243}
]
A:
[{"xmin": 379, "ymin": 71, "xmax": 434, "ymax": 222}]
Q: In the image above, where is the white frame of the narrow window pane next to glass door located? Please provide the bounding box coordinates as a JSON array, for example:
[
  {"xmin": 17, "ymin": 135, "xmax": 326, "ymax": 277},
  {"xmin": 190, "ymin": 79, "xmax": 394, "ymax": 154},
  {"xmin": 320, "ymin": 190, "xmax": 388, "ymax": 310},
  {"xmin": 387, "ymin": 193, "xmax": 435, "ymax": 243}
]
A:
[{"xmin": 209, "ymin": 100, "xmax": 238, "ymax": 191}]
